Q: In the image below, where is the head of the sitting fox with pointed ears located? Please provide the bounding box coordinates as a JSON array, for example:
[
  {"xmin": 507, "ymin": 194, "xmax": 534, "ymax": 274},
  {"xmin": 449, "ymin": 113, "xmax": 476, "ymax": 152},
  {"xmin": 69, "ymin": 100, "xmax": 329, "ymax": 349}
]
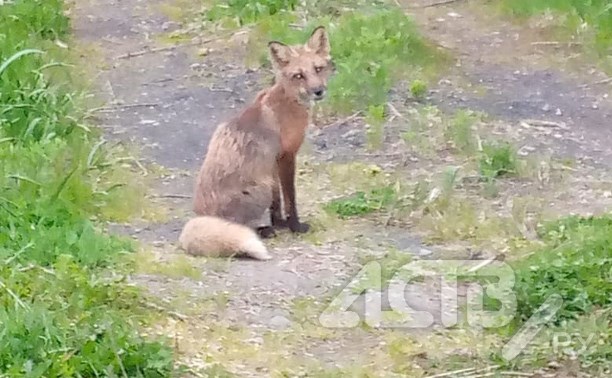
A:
[{"xmin": 268, "ymin": 26, "xmax": 334, "ymax": 104}]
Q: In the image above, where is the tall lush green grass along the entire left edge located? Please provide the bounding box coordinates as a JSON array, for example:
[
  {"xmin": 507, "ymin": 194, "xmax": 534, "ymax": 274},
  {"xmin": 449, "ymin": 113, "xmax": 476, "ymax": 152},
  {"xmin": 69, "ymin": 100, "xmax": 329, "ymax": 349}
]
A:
[{"xmin": 0, "ymin": 0, "xmax": 174, "ymax": 377}]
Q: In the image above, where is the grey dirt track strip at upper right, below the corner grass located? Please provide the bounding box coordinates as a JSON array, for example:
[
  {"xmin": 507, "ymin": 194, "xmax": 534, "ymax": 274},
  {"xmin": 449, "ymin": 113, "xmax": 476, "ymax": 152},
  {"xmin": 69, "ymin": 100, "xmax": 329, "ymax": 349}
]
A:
[{"xmin": 403, "ymin": 0, "xmax": 612, "ymax": 168}]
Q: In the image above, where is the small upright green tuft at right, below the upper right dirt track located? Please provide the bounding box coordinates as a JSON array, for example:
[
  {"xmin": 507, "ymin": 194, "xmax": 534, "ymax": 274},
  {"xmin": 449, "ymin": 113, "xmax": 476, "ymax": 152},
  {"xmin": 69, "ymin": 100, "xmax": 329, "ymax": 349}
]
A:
[{"xmin": 479, "ymin": 142, "xmax": 517, "ymax": 178}]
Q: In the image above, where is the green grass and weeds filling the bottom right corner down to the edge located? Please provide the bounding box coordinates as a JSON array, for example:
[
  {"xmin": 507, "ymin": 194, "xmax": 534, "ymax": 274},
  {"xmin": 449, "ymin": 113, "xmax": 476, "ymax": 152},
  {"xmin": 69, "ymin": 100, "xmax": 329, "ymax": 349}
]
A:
[{"xmin": 485, "ymin": 215, "xmax": 612, "ymax": 376}]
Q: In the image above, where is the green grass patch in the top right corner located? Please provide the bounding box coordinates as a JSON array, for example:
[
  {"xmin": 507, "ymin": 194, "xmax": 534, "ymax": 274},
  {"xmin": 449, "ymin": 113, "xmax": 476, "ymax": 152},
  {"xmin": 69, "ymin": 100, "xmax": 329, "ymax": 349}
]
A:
[{"xmin": 499, "ymin": 0, "xmax": 612, "ymax": 58}]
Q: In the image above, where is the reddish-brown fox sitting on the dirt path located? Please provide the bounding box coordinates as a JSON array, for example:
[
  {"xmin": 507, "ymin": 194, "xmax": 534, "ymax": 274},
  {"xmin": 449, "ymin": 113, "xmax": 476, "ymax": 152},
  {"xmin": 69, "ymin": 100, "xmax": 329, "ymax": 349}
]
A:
[{"xmin": 179, "ymin": 26, "xmax": 335, "ymax": 260}]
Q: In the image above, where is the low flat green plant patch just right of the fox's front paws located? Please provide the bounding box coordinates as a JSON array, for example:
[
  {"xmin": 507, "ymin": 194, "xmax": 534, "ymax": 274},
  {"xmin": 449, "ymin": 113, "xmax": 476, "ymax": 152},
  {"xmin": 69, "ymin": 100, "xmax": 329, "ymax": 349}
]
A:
[{"xmin": 325, "ymin": 187, "xmax": 396, "ymax": 218}]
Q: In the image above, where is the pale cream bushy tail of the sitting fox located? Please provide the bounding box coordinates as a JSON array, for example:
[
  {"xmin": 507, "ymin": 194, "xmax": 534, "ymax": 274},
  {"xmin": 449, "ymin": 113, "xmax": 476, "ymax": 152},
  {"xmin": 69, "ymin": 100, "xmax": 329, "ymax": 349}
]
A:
[{"xmin": 179, "ymin": 216, "xmax": 272, "ymax": 260}]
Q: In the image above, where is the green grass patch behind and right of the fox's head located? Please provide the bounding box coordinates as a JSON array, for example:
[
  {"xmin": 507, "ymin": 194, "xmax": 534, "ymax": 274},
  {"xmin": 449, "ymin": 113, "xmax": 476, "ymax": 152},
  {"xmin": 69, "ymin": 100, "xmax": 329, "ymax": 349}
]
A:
[{"xmin": 204, "ymin": 0, "xmax": 447, "ymax": 114}]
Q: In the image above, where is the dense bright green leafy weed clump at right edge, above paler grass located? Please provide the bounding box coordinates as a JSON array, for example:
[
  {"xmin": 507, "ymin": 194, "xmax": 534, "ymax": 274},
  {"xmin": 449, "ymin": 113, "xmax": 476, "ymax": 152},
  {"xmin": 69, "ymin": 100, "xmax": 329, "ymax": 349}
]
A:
[{"xmin": 515, "ymin": 216, "xmax": 612, "ymax": 324}]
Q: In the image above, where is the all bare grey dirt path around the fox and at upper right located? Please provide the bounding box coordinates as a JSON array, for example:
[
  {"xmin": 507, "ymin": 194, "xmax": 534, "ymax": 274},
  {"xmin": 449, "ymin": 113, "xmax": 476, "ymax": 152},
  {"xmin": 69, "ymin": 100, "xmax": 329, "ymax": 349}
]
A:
[{"xmin": 69, "ymin": 0, "xmax": 612, "ymax": 376}]
